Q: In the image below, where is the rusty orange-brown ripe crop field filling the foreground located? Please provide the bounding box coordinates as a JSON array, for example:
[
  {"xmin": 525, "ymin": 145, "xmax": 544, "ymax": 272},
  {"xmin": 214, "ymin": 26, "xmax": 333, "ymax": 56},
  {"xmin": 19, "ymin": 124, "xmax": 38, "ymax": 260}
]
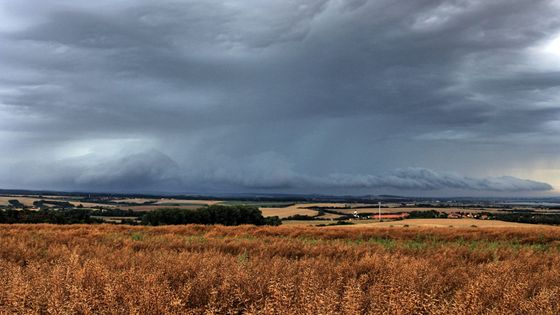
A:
[{"xmin": 0, "ymin": 225, "xmax": 560, "ymax": 314}]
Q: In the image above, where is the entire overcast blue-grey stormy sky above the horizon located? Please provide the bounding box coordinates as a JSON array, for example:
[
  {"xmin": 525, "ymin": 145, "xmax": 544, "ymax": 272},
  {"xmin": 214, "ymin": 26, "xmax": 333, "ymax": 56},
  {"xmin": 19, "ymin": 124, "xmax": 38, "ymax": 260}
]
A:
[{"xmin": 0, "ymin": 0, "xmax": 560, "ymax": 196}]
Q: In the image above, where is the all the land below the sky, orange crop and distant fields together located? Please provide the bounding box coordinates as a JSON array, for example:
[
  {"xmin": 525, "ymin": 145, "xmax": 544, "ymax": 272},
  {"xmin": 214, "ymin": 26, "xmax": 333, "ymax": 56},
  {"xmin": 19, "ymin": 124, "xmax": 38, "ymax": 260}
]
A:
[{"xmin": 0, "ymin": 194, "xmax": 560, "ymax": 314}]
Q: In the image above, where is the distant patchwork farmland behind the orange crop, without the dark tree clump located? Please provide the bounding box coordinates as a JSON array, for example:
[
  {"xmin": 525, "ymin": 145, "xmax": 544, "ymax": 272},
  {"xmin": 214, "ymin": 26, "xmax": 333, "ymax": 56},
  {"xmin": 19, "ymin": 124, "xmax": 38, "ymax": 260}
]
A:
[{"xmin": 5, "ymin": 192, "xmax": 560, "ymax": 226}]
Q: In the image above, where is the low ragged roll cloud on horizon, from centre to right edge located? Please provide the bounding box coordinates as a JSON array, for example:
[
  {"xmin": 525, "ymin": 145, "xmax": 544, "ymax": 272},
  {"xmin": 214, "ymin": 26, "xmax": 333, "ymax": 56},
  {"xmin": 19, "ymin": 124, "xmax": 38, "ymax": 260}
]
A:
[{"xmin": 185, "ymin": 157, "xmax": 553, "ymax": 192}]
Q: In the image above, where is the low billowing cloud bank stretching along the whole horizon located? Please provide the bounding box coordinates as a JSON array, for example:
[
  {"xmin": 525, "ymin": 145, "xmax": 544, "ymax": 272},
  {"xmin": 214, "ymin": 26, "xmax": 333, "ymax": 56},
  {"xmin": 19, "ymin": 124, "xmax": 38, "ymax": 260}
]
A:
[{"xmin": 2, "ymin": 150, "xmax": 553, "ymax": 193}]
